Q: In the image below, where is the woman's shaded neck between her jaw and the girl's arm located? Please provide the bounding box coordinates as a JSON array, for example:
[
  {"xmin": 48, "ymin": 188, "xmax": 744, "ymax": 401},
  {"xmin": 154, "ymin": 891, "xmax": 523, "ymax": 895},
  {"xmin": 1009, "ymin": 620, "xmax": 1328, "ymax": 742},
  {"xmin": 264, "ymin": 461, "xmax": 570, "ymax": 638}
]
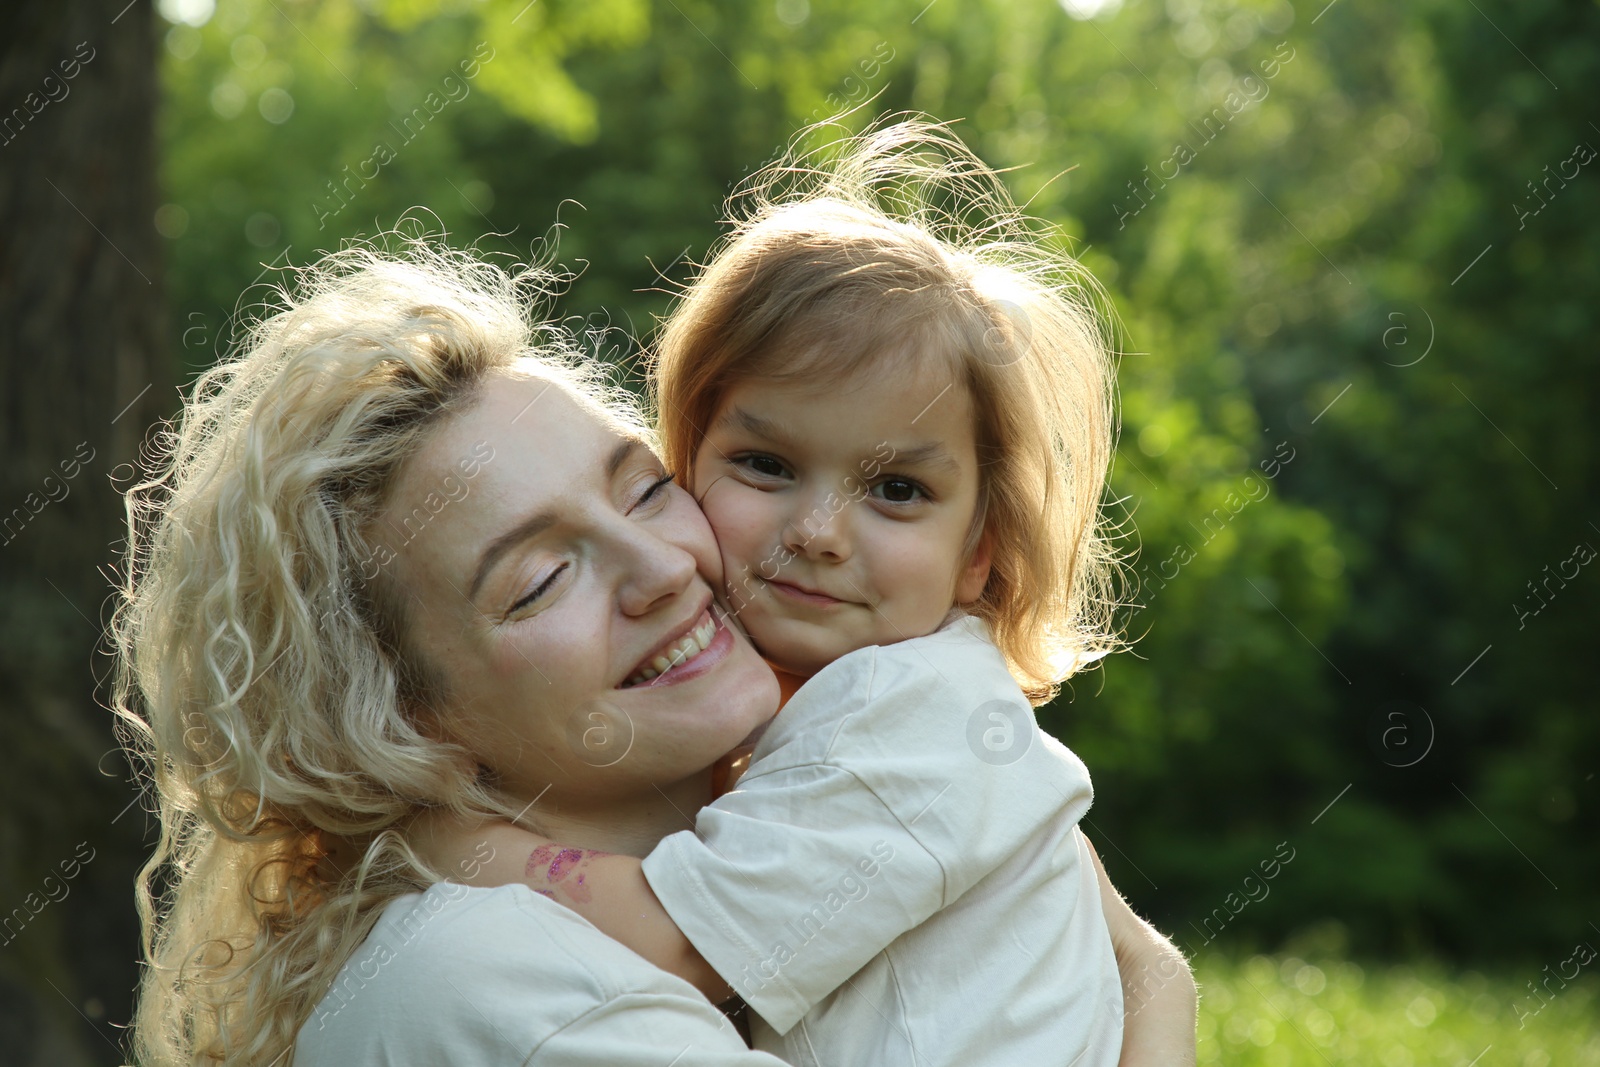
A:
[{"xmin": 522, "ymin": 768, "xmax": 712, "ymax": 857}]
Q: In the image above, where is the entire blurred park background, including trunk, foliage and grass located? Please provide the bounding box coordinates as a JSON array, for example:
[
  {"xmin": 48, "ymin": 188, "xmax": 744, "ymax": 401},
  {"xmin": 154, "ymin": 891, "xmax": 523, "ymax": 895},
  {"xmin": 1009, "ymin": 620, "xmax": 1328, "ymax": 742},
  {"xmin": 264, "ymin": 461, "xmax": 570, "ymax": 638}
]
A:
[{"xmin": 0, "ymin": 0, "xmax": 1600, "ymax": 1067}]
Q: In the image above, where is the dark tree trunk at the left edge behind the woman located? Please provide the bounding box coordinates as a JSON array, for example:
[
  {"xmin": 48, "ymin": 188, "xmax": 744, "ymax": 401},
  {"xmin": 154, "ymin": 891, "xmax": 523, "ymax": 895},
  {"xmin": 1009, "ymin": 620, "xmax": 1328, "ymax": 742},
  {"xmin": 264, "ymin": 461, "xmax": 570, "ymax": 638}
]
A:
[{"xmin": 0, "ymin": 0, "xmax": 173, "ymax": 1064}]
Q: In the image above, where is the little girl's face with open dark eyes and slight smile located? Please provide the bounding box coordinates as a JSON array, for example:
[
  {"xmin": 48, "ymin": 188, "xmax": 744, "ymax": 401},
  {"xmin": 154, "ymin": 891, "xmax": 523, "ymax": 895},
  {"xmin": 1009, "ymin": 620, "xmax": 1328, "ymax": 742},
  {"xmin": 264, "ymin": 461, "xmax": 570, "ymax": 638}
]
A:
[{"xmin": 694, "ymin": 358, "xmax": 989, "ymax": 677}]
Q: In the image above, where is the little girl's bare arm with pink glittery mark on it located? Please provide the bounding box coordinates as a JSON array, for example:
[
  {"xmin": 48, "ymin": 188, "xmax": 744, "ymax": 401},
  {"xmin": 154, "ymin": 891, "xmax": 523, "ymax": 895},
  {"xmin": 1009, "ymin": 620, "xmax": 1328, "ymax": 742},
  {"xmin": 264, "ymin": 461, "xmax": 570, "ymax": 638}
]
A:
[{"xmin": 411, "ymin": 813, "xmax": 733, "ymax": 1005}]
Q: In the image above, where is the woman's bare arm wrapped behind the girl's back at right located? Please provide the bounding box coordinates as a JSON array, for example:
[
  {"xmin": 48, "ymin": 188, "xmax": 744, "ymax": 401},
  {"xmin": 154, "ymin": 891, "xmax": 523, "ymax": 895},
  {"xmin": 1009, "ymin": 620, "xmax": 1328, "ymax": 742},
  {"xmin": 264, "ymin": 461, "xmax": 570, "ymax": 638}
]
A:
[{"xmin": 1085, "ymin": 838, "xmax": 1200, "ymax": 1067}]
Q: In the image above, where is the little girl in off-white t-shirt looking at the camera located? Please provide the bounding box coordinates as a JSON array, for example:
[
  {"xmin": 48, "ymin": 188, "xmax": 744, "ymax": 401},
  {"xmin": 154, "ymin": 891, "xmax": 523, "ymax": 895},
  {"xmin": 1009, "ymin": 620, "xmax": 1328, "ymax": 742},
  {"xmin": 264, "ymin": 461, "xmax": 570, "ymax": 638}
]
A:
[{"xmin": 419, "ymin": 123, "xmax": 1123, "ymax": 1067}]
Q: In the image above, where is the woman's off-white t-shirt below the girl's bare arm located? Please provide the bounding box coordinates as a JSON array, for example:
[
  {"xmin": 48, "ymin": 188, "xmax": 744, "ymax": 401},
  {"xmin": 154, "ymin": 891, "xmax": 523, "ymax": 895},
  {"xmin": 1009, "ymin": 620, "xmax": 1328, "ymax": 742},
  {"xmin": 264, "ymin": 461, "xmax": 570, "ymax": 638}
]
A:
[{"xmin": 293, "ymin": 883, "xmax": 782, "ymax": 1067}]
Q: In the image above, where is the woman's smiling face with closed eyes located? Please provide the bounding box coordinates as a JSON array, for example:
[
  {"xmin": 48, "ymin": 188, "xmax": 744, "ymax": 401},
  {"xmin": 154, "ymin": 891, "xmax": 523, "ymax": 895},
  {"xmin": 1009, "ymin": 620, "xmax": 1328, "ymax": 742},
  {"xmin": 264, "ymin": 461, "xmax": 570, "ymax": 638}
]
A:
[{"xmin": 384, "ymin": 374, "xmax": 778, "ymax": 806}]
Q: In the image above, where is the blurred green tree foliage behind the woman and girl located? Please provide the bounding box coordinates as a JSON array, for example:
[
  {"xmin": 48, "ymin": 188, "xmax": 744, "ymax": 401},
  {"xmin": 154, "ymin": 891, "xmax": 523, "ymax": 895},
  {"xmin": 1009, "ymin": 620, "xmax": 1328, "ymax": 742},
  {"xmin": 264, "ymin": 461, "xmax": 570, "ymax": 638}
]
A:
[{"xmin": 160, "ymin": 0, "xmax": 1600, "ymax": 959}]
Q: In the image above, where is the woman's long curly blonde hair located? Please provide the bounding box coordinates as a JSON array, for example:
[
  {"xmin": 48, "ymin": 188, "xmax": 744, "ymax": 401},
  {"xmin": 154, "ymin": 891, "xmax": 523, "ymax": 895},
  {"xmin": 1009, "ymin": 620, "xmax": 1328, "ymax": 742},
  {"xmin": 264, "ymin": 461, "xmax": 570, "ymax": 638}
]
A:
[{"xmin": 112, "ymin": 240, "xmax": 640, "ymax": 1065}]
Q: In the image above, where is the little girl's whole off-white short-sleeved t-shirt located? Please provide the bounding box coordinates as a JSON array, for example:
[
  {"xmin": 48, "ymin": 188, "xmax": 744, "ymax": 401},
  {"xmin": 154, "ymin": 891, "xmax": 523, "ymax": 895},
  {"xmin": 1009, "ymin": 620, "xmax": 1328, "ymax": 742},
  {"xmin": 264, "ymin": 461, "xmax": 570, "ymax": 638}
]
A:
[{"xmin": 645, "ymin": 616, "xmax": 1122, "ymax": 1067}]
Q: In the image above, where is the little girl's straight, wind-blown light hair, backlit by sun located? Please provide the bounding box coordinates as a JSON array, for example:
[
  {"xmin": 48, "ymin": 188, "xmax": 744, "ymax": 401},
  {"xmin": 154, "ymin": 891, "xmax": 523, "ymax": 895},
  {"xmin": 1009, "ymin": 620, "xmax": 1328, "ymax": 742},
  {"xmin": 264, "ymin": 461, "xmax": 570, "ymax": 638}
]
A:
[{"xmin": 653, "ymin": 118, "xmax": 1117, "ymax": 704}]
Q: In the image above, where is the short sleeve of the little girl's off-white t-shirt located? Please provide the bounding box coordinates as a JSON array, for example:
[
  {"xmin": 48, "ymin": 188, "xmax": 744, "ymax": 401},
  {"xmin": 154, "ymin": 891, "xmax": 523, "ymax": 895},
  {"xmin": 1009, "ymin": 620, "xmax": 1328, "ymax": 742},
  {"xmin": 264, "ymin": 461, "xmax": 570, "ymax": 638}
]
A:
[{"xmin": 645, "ymin": 627, "xmax": 1091, "ymax": 1033}]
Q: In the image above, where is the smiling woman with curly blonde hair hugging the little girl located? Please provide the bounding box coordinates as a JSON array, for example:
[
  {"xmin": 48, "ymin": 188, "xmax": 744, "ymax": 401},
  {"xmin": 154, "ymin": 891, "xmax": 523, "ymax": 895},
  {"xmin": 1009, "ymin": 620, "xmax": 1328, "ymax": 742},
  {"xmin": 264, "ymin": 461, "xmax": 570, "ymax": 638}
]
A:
[{"xmin": 114, "ymin": 246, "xmax": 1194, "ymax": 1067}]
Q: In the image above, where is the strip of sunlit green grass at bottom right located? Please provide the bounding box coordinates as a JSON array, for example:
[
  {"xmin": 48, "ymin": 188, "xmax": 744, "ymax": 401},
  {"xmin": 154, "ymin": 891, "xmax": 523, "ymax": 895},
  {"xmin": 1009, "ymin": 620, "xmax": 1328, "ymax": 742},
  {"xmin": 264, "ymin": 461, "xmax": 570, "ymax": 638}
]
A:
[{"xmin": 1195, "ymin": 955, "xmax": 1600, "ymax": 1067}]
